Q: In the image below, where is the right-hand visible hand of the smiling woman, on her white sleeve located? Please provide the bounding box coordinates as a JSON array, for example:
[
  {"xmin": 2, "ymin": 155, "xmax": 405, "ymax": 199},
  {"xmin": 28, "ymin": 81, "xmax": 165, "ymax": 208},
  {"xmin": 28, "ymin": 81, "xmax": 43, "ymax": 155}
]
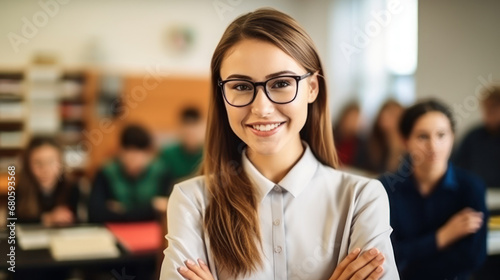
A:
[{"xmin": 329, "ymin": 248, "xmax": 385, "ymax": 280}]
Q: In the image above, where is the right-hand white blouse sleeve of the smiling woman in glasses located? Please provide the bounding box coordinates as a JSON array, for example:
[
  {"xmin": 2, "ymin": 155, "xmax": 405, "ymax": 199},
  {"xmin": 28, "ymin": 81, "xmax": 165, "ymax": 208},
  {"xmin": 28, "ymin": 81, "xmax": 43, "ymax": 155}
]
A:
[{"xmin": 349, "ymin": 180, "xmax": 399, "ymax": 280}]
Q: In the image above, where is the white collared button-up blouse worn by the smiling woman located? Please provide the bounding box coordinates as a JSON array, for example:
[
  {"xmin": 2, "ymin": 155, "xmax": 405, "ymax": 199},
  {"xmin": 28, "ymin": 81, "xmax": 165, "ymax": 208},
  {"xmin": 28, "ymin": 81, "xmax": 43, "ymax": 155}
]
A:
[{"xmin": 160, "ymin": 143, "xmax": 399, "ymax": 280}]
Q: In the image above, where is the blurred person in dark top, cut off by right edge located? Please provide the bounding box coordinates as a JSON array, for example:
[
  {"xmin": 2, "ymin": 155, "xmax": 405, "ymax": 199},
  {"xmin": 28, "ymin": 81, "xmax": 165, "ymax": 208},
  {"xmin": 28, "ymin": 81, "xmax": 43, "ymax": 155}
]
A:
[{"xmin": 455, "ymin": 86, "xmax": 500, "ymax": 188}]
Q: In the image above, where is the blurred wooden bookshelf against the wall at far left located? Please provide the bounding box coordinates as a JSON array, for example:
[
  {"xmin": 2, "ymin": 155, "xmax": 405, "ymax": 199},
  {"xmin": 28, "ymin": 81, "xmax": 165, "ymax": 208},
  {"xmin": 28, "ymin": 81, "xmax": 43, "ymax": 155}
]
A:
[{"xmin": 0, "ymin": 69, "xmax": 98, "ymax": 182}]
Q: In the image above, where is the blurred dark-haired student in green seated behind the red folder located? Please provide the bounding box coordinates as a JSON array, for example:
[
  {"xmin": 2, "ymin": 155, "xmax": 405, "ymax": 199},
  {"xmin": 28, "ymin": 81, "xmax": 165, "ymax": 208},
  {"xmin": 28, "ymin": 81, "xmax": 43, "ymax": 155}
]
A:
[{"xmin": 88, "ymin": 125, "xmax": 171, "ymax": 222}]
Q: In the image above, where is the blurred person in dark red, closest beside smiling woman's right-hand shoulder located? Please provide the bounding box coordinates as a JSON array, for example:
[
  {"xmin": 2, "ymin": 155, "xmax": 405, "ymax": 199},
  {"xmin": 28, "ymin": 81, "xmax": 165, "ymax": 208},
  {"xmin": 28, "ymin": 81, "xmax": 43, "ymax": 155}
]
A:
[{"xmin": 333, "ymin": 102, "xmax": 363, "ymax": 167}]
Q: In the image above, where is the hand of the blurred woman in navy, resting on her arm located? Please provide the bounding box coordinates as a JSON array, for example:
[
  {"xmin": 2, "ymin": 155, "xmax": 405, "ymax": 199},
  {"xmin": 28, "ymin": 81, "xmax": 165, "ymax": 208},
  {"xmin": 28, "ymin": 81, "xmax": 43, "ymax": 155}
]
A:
[{"xmin": 436, "ymin": 207, "xmax": 483, "ymax": 249}]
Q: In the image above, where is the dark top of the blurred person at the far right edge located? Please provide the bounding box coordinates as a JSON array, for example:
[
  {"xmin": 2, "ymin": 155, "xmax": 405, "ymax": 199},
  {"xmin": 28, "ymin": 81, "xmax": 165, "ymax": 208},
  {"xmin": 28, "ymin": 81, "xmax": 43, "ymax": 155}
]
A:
[{"xmin": 454, "ymin": 126, "xmax": 500, "ymax": 188}]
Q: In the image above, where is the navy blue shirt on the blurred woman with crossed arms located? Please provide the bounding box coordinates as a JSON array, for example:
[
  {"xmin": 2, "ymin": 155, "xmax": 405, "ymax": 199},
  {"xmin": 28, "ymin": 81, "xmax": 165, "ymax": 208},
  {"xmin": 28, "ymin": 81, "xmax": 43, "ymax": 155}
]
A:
[{"xmin": 379, "ymin": 161, "xmax": 488, "ymax": 280}]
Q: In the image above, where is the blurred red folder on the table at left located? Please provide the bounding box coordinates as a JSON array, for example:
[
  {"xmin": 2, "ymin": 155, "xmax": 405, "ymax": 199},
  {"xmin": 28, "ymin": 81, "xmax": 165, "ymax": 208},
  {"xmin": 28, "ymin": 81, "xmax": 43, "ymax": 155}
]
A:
[{"xmin": 106, "ymin": 222, "xmax": 162, "ymax": 253}]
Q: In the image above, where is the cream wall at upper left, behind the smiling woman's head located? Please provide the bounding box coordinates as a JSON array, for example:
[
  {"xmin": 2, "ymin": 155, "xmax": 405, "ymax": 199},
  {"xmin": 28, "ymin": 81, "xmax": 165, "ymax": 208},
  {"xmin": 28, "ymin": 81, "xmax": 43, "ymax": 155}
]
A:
[{"xmin": 0, "ymin": 0, "xmax": 327, "ymax": 75}]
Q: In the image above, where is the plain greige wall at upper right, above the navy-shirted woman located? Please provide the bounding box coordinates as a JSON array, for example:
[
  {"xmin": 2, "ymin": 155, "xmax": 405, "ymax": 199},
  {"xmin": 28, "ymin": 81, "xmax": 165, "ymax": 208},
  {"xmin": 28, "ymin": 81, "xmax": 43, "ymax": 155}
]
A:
[{"xmin": 416, "ymin": 0, "xmax": 500, "ymax": 138}]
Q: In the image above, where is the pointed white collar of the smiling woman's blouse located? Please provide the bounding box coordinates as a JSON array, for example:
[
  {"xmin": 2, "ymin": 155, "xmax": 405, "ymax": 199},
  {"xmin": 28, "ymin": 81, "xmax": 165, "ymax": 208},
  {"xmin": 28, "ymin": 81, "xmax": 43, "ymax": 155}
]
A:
[{"xmin": 242, "ymin": 141, "xmax": 319, "ymax": 202}]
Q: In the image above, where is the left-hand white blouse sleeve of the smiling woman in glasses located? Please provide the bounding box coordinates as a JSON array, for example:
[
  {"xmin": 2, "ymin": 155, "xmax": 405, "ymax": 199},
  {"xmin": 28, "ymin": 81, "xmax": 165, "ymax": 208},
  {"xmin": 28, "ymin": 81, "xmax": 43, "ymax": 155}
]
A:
[{"xmin": 160, "ymin": 185, "xmax": 217, "ymax": 280}]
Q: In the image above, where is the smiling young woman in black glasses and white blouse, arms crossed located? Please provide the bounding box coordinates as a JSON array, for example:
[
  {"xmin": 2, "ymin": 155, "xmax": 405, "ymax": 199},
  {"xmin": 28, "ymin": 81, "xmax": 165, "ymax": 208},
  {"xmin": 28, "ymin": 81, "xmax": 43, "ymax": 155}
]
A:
[{"xmin": 160, "ymin": 9, "xmax": 399, "ymax": 280}]
